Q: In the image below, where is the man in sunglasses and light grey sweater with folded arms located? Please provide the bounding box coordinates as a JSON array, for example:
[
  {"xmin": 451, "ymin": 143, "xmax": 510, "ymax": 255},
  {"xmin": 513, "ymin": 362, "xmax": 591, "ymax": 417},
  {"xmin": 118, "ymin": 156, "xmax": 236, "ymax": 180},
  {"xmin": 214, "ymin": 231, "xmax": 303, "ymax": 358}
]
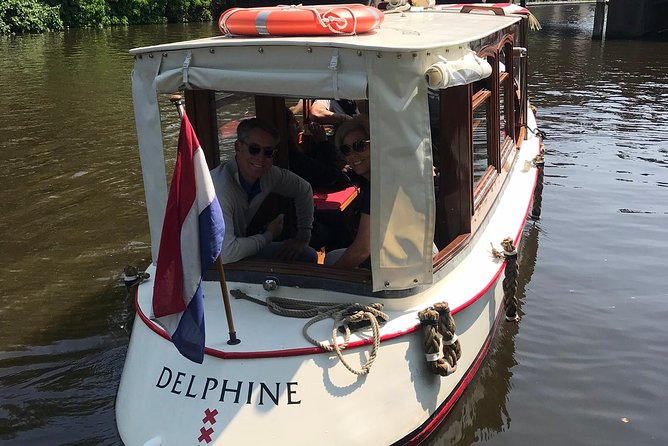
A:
[{"xmin": 211, "ymin": 118, "xmax": 317, "ymax": 263}]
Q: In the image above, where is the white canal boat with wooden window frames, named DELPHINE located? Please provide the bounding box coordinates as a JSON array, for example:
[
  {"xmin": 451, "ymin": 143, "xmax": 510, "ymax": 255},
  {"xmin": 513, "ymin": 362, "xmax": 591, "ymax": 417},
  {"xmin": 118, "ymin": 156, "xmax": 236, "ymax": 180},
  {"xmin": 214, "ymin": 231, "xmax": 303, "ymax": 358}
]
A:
[{"xmin": 116, "ymin": 2, "xmax": 544, "ymax": 446}]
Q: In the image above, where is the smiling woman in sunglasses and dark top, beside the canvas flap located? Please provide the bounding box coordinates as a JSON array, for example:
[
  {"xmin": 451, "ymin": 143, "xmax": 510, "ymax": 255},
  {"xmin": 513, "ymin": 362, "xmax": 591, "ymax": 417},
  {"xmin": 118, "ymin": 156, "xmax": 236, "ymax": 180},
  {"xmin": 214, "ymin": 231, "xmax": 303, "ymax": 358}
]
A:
[{"xmin": 325, "ymin": 115, "xmax": 371, "ymax": 268}]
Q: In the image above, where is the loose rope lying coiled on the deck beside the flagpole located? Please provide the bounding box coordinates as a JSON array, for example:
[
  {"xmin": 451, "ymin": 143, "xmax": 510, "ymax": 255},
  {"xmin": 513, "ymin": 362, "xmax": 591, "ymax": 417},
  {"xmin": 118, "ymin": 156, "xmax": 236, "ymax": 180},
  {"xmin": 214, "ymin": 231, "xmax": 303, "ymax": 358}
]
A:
[{"xmin": 230, "ymin": 290, "xmax": 389, "ymax": 376}]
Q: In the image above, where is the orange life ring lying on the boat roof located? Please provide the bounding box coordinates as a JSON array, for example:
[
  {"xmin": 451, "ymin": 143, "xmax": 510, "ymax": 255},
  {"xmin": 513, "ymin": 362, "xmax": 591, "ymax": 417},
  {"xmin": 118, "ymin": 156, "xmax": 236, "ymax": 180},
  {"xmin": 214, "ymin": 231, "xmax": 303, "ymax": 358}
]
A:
[{"xmin": 218, "ymin": 4, "xmax": 384, "ymax": 36}]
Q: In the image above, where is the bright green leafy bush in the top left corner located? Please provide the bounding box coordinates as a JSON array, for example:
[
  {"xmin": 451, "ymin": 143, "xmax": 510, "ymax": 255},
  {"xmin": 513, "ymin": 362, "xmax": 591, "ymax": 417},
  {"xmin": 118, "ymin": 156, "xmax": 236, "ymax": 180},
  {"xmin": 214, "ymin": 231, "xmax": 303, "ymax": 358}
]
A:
[{"xmin": 0, "ymin": 0, "xmax": 63, "ymax": 34}]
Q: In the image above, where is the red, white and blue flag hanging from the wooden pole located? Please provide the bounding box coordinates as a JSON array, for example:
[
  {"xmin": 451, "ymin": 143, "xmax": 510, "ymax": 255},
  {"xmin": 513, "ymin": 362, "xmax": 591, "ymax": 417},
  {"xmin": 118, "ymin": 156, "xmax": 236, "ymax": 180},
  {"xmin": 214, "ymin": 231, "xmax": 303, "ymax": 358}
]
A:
[{"xmin": 153, "ymin": 113, "xmax": 225, "ymax": 364}]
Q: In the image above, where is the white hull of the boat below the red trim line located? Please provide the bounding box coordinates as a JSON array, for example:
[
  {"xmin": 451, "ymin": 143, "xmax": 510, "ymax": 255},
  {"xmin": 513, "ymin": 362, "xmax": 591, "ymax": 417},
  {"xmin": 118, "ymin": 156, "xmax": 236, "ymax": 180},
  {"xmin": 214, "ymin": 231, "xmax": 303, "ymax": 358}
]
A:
[{"xmin": 116, "ymin": 277, "xmax": 503, "ymax": 446}]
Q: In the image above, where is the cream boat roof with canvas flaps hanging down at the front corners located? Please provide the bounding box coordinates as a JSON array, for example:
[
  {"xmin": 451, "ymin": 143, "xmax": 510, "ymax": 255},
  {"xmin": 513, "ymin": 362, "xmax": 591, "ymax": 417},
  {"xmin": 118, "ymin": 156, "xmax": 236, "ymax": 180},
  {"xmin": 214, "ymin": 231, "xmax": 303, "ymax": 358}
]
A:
[{"xmin": 132, "ymin": 12, "xmax": 520, "ymax": 291}]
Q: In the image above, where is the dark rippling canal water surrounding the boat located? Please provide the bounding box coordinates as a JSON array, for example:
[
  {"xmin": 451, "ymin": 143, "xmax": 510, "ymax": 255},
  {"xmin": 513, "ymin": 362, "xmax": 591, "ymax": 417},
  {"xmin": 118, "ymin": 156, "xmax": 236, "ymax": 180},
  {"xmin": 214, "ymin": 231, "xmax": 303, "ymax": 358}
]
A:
[{"xmin": 0, "ymin": 4, "xmax": 668, "ymax": 446}]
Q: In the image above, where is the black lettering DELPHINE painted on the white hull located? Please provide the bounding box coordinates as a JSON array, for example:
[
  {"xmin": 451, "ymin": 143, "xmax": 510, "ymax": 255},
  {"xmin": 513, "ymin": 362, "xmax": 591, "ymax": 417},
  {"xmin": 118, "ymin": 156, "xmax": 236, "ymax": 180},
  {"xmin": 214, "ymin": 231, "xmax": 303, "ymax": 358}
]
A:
[{"xmin": 155, "ymin": 366, "xmax": 301, "ymax": 406}]
